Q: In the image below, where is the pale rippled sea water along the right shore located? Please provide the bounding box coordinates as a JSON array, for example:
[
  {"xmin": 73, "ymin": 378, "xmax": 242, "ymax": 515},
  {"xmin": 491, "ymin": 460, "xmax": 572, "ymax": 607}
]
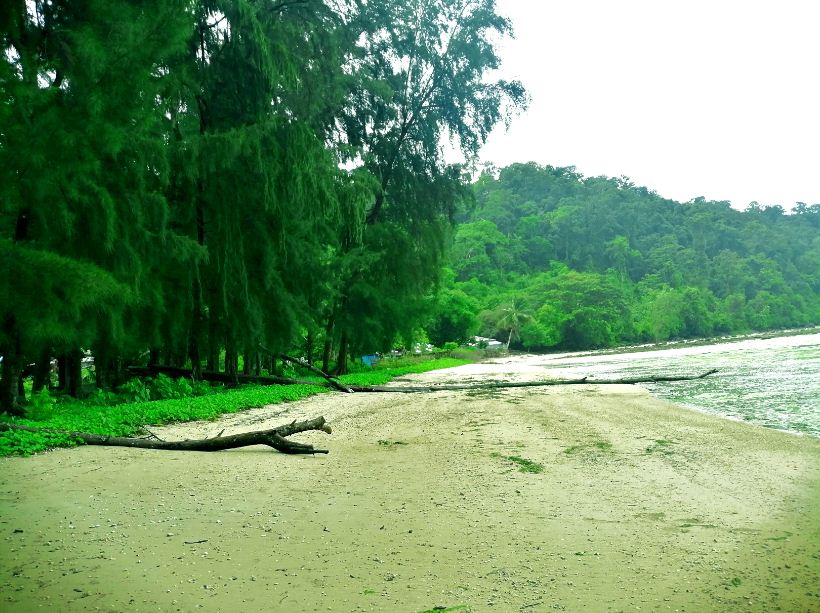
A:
[{"xmin": 538, "ymin": 333, "xmax": 820, "ymax": 437}]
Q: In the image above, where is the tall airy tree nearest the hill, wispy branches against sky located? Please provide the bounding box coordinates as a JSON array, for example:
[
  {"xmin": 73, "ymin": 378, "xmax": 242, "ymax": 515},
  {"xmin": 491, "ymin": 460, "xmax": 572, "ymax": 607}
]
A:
[{"xmin": 328, "ymin": 0, "xmax": 525, "ymax": 369}]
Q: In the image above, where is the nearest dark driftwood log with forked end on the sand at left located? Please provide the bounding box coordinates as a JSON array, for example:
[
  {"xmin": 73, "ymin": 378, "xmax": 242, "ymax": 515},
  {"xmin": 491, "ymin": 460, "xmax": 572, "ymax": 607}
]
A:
[{"xmin": 0, "ymin": 417, "xmax": 331, "ymax": 454}]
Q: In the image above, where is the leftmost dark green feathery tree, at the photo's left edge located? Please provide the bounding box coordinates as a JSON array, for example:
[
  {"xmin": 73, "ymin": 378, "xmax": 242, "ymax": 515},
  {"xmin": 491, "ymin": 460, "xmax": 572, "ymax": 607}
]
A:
[{"xmin": 0, "ymin": 0, "xmax": 188, "ymax": 412}]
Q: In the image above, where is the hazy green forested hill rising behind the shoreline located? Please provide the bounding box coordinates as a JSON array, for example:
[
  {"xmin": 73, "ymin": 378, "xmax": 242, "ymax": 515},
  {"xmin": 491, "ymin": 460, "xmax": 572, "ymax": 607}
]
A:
[{"xmin": 429, "ymin": 164, "xmax": 820, "ymax": 350}]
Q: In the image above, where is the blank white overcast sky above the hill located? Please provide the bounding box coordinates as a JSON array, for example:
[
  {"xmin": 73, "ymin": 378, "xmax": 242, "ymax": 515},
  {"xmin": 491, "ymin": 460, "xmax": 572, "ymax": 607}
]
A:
[{"xmin": 481, "ymin": 0, "xmax": 820, "ymax": 209}]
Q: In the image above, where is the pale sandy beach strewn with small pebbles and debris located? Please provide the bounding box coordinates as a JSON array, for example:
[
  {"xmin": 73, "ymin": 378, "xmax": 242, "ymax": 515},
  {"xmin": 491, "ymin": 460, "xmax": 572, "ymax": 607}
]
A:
[{"xmin": 0, "ymin": 358, "xmax": 820, "ymax": 613}]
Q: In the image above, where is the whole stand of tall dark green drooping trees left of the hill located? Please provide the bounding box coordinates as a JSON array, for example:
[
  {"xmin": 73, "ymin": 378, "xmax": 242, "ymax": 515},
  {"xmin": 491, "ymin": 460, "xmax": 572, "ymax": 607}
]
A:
[{"xmin": 0, "ymin": 0, "xmax": 526, "ymax": 413}]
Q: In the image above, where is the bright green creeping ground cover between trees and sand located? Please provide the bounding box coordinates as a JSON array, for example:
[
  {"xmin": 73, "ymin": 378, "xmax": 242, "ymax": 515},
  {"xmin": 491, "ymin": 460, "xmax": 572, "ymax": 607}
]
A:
[{"xmin": 0, "ymin": 358, "xmax": 467, "ymax": 456}]
